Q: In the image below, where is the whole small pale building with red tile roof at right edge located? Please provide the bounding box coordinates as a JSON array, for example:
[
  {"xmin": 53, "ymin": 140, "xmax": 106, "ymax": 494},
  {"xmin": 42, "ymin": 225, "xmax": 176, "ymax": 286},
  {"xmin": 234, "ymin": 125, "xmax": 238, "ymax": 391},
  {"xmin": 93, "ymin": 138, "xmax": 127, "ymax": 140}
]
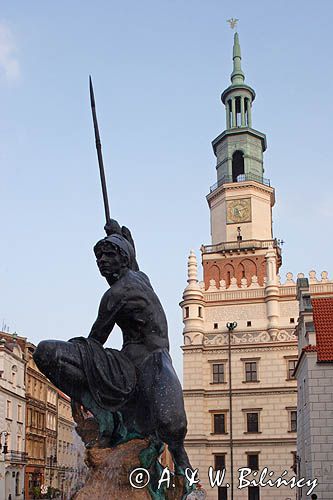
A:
[{"xmin": 295, "ymin": 278, "xmax": 333, "ymax": 500}]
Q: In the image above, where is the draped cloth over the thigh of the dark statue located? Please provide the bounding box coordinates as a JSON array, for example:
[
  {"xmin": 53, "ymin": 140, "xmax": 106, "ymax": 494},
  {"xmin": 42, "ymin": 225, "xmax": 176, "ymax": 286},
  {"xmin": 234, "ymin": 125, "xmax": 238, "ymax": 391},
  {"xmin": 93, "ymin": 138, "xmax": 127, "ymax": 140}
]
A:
[{"xmin": 69, "ymin": 337, "xmax": 136, "ymax": 411}]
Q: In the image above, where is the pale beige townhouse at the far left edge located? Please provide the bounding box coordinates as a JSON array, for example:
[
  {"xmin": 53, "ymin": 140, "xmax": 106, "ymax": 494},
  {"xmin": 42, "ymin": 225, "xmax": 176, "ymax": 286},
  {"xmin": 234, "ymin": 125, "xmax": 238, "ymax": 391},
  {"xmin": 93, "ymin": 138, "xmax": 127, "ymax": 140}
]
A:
[{"xmin": 0, "ymin": 332, "xmax": 27, "ymax": 500}]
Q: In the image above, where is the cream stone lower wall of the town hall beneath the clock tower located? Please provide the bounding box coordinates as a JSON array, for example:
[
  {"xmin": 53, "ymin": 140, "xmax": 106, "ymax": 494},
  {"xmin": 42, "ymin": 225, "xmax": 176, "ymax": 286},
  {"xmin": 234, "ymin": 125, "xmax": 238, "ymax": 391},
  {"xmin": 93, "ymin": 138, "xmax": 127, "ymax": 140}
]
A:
[{"xmin": 181, "ymin": 270, "xmax": 333, "ymax": 500}]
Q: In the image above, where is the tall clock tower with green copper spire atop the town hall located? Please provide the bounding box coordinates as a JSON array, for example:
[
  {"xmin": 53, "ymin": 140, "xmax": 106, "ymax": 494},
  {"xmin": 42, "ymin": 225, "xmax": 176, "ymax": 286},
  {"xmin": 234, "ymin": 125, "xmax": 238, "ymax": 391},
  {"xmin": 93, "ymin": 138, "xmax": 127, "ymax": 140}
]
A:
[{"xmin": 202, "ymin": 33, "xmax": 281, "ymax": 289}]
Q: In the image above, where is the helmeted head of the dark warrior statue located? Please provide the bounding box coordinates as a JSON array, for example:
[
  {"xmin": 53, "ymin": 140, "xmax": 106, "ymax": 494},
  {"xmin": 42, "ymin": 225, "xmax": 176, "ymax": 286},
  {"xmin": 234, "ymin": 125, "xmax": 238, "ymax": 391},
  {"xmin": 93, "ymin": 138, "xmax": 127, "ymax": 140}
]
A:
[{"xmin": 94, "ymin": 234, "xmax": 135, "ymax": 281}]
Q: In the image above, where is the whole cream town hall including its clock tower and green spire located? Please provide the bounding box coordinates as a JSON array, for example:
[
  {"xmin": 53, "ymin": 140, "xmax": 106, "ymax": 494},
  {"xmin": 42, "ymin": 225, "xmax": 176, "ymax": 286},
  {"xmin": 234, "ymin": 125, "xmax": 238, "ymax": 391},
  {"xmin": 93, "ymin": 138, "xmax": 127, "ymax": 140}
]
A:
[{"xmin": 181, "ymin": 33, "xmax": 333, "ymax": 500}]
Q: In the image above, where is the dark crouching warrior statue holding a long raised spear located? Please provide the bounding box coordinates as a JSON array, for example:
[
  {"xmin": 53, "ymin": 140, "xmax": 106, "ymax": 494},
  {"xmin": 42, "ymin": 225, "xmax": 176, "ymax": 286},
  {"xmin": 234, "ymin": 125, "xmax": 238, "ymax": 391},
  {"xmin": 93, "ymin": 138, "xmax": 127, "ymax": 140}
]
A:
[{"xmin": 34, "ymin": 79, "xmax": 190, "ymax": 484}]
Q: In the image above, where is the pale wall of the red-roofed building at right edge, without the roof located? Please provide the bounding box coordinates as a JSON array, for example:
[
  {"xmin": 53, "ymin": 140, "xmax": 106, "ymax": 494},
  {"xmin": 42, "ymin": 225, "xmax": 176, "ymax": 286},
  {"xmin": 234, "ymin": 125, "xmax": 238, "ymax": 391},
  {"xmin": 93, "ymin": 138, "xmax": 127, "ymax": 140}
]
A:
[{"xmin": 296, "ymin": 290, "xmax": 333, "ymax": 500}]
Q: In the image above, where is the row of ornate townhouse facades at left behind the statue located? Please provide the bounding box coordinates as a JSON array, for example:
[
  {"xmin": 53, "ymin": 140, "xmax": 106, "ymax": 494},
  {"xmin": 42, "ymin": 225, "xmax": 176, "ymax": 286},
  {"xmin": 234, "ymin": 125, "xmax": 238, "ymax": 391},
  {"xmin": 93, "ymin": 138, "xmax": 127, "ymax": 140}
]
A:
[{"xmin": 0, "ymin": 332, "xmax": 86, "ymax": 500}]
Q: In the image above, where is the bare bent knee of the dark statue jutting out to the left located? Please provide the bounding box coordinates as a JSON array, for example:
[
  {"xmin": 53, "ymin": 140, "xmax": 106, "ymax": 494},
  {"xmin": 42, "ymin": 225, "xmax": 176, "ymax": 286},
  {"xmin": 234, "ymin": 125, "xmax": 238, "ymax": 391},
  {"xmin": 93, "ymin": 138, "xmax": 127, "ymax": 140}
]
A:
[{"xmin": 33, "ymin": 340, "xmax": 88, "ymax": 402}]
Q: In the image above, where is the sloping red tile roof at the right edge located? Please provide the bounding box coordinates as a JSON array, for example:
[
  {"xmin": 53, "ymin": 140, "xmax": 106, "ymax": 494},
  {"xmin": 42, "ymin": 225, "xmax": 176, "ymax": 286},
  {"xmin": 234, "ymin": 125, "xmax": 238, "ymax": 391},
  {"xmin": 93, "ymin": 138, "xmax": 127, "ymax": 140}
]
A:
[{"xmin": 311, "ymin": 297, "xmax": 333, "ymax": 362}]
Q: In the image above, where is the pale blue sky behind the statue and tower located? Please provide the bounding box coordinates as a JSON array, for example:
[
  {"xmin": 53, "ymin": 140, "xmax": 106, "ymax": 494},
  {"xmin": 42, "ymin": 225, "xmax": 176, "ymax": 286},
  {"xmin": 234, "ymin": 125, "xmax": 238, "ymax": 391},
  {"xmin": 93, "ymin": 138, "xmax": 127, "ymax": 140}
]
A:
[{"xmin": 0, "ymin": 0, "xmax": 333, "ymax": 373}]
